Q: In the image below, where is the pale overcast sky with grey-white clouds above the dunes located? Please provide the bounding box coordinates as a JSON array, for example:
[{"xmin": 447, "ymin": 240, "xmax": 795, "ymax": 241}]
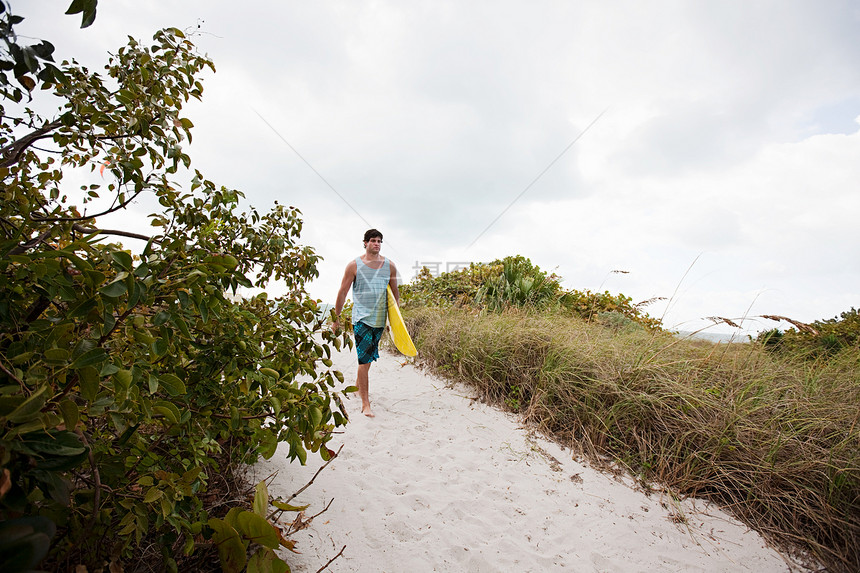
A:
[{"xmin": 11, "ymin": 0, "xmax": 860, "ymax": 333}]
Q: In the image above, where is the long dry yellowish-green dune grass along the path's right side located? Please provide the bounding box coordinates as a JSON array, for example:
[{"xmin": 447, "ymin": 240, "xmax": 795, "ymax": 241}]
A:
[{"xmin": 406, "ymin": 308, "xmax": 860, "ymax": 571}]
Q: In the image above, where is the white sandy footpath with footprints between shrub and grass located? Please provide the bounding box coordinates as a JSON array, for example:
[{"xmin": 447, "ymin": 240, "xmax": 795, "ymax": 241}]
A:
[{"xmin": 254, "ymin": 344, "xmax": 801, "ymax": 573}]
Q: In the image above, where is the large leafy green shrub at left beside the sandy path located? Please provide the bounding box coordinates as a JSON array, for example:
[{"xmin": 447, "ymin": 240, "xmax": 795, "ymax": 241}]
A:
[{"xmin": 0, "ymin": 6, "xmax": 351, "ymax": 571}]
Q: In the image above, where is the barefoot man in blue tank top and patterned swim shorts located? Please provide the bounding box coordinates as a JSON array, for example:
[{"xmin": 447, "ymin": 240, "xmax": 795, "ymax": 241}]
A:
[{"xmin": 332, "ymin": 229, "xmax": 400, "ymax": 418}]
